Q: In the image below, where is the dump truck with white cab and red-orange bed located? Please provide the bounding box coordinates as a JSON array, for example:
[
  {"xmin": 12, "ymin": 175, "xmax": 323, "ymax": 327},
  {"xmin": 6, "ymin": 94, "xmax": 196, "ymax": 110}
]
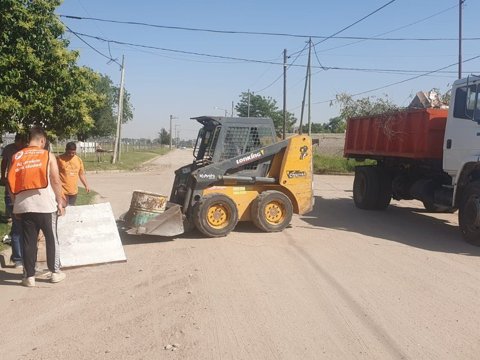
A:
[{"xmin": 344, "ymin": 76, "xmax": 480, "ymax": 246}]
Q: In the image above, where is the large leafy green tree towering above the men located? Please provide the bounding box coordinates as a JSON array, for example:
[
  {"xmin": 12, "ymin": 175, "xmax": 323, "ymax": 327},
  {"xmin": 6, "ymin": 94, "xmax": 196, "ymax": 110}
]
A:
[{"xmin": 0, "ymin": 0, "xmax": 100, "ymax": 137}]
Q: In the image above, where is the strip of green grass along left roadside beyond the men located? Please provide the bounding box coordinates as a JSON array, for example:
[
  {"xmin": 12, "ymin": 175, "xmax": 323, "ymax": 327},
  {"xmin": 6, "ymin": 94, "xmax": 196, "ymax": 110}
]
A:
[{"xmin": 79, "ymin": 148, "xmax": 168, "ymax": 171}]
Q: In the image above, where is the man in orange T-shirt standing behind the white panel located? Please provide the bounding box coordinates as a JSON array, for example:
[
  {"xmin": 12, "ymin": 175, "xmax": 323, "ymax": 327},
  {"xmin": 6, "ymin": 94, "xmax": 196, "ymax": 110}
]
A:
[{"xmin": 57, "ymin": 142, "xmax": 90, "ymax": 205}]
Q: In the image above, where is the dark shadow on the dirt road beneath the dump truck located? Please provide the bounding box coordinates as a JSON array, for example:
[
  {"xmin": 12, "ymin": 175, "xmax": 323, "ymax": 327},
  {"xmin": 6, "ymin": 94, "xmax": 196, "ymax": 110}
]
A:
[{"xmin": 301, "ymin": 196, "xmax": 480, "ymax": 256}]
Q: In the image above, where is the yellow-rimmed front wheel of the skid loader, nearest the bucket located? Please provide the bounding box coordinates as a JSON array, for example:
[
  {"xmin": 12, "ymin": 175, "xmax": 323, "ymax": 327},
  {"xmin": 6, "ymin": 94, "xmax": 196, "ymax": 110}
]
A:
[{"xmin": 193, "ymin": 194, "xmax": 238, "ymax": 237}]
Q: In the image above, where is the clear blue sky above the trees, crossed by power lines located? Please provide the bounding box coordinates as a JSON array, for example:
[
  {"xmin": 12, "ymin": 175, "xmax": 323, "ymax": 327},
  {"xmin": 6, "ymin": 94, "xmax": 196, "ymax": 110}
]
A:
[{"xmin": 56, "ymin": 0, "xmax": 480, "ymax": 139}]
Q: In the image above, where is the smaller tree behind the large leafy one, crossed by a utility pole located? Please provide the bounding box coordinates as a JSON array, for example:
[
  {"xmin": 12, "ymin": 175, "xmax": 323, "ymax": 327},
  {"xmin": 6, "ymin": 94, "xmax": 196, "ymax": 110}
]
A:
[{"xmin": 78, "ymin": 75, "xmax": 133, "ymax": 141}]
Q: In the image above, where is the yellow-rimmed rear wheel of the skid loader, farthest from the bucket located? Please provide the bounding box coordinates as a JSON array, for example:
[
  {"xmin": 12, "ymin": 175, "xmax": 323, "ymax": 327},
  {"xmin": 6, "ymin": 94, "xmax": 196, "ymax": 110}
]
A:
[{"xmin": 250, "ymin": 190, "xmax": 293, "ymax": 232}]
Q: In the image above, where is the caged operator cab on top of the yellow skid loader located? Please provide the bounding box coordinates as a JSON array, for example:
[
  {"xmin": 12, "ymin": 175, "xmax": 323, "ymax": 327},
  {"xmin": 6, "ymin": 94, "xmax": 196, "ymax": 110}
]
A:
[{"xmin": 193, "ymin": 116, "xmax": 277, "ymax": 163}]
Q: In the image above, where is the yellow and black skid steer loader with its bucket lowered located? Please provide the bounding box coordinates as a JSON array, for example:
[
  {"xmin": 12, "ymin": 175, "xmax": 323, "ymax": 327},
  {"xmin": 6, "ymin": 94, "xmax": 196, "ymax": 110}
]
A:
[{"xmin": 125, "ymin": 116, "xmax": 313, "ymax": 237}]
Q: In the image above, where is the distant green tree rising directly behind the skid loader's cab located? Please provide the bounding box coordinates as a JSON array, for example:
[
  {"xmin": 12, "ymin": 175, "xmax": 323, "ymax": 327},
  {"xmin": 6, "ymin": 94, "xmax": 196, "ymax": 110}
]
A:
[{"xmin": 235, "ymin": 92, "xmax": 297, "ymax": 134}]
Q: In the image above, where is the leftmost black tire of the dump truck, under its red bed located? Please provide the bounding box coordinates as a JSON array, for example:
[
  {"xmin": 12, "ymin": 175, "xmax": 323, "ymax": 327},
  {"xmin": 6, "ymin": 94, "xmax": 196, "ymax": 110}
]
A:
[{"xmin": 353, "ymin": 166, "xmax": 392, "ymax": 210}]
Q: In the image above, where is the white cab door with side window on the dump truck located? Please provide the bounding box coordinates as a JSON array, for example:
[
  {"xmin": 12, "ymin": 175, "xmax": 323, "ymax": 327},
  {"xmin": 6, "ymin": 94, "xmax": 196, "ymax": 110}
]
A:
[{"xmin": 443, "ymin": 81, "xmax": 480, "ymax": 177}]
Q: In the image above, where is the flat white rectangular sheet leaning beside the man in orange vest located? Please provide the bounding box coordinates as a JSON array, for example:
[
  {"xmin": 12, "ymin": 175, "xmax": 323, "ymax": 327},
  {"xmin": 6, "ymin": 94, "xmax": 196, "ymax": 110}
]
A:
[{"xmin": 58, "ymin": 203, "xmax": 127, "ymax": 267}]
